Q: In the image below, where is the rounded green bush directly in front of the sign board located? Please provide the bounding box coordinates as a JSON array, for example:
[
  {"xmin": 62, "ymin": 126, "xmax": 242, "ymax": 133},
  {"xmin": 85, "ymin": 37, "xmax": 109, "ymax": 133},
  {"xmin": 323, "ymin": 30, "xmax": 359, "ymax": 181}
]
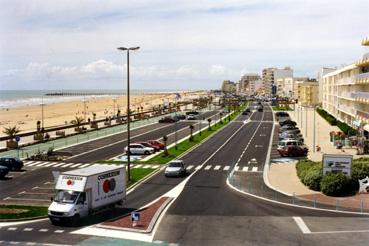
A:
[{"xmin": 320, "ymin": 173, "xmax": 350, "ymax": 196}]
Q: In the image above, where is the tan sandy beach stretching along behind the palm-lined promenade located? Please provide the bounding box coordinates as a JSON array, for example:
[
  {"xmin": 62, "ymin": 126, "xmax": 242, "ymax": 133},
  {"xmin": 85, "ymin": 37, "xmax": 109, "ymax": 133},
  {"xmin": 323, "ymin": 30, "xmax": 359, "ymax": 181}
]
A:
[{"xmin": 0, "ymin": 92, "xmax": 204, "ymax": 136}]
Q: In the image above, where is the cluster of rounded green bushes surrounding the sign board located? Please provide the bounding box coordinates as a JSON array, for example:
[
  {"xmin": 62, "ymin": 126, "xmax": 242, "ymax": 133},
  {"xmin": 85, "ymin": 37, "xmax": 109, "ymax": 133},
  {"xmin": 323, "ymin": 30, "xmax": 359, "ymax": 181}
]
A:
[{"xmin": 296, "ymin": 158, "xmax": 369, "ymax": 196}]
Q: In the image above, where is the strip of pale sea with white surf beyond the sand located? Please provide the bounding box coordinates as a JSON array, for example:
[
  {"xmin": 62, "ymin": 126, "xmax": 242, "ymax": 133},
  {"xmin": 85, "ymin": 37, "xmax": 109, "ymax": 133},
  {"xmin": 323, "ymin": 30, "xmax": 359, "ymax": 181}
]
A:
[{"xmin": 0, "ymin": 90, "xmax": 175, "ymax": 109}]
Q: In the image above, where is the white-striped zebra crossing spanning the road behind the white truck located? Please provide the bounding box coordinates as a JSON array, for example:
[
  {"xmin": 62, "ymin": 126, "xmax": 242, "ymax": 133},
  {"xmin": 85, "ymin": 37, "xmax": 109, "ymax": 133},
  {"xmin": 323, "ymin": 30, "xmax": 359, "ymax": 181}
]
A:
[{"xmin": 24, "ymin": 161, "xmax": 259, "ymax": 172}]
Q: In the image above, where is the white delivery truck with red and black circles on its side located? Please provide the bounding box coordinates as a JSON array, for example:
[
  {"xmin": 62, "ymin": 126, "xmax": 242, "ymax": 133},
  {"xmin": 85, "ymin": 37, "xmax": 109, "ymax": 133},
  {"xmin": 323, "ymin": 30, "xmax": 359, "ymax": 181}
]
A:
[{"xmin": 48, "ymin": 165, "xmax": 126, "ymax": 224}]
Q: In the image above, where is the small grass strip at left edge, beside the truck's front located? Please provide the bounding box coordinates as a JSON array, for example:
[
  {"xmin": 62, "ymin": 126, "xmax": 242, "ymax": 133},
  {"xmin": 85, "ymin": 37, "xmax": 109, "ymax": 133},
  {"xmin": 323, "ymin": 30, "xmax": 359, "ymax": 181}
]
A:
[{"xmin": 0, "ymin": 205, "xmax": 47, "ymax": 219}]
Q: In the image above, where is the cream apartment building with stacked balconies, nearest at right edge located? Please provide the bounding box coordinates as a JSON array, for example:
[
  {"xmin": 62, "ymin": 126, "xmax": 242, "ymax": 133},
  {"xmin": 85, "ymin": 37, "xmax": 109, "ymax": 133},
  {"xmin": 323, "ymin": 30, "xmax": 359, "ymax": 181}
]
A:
[{"xmin": 322, "ymin": 38, "xmax": 369, "ymax": 134}]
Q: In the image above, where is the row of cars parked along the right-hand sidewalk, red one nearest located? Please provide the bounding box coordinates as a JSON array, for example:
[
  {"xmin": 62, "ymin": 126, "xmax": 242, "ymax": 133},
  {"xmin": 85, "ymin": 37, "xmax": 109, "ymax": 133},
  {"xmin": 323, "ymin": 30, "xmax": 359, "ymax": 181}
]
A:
[{"xmin": 276, "ymin": 112, "xmax": 309, "ymax": 157}]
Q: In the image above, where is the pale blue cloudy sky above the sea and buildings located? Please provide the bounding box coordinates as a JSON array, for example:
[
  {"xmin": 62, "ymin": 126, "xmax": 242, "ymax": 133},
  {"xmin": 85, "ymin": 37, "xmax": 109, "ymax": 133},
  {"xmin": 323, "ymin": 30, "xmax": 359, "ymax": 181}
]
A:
[{"xmin": 0, "ymin": 0, "xmax": 369, "ymax": 90}]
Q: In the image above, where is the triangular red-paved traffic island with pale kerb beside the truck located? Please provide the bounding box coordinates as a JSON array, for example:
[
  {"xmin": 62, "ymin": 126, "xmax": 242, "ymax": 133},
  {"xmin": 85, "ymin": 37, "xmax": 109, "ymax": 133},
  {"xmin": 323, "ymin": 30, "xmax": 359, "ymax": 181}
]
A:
[{"xmin": 97, "ymin": 197, "xmax": 173, "ymax": 233}]
